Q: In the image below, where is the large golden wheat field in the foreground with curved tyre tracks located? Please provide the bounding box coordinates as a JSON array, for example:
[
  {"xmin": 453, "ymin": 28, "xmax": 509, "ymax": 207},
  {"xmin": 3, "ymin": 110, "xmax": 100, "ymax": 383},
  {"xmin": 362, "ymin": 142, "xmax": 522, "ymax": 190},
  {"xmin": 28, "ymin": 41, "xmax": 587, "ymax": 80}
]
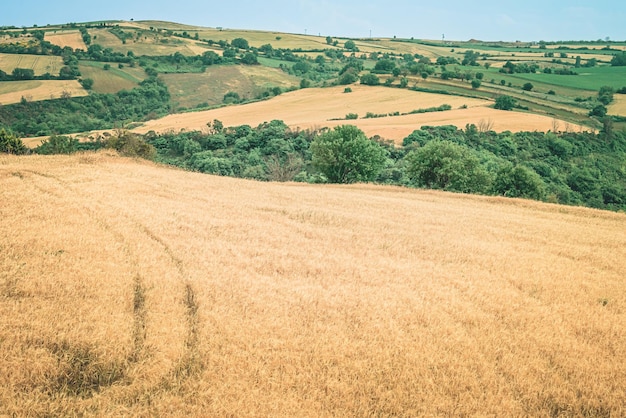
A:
[{"xmin": 0, "ymin": 153, "xmax": 626, "ymax": 417}]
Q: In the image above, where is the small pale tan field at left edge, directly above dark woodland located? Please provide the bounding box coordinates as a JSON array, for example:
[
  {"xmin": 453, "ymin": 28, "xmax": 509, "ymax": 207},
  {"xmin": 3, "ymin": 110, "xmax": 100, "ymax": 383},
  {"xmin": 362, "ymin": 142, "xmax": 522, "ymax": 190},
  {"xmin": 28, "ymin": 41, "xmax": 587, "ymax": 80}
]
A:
[{"xmin": 0, "ymin": 80, "xmax": 87, "ymax": 104}]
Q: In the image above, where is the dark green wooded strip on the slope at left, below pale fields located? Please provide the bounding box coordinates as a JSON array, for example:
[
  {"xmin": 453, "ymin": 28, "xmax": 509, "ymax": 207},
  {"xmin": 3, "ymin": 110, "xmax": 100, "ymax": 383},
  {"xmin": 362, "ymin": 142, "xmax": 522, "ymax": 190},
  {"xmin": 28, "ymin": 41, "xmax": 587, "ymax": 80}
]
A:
[{"xmin": 0, "ymin": 78, "xmax": 170, "ymax": 136}]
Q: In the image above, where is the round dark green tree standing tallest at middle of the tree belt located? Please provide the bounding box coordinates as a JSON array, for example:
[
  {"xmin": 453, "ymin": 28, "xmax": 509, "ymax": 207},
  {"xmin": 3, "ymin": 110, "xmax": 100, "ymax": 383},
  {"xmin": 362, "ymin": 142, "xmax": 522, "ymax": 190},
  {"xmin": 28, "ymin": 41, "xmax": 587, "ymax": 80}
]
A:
[{"xmin": 311, "ymin": 125, "xmax": 387, "ymax": 183}]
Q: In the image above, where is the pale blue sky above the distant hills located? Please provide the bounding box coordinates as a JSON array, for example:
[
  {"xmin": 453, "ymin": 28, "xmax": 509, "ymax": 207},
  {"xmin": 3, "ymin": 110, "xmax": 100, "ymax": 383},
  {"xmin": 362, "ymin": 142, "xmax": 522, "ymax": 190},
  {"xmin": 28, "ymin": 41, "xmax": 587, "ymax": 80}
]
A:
[{"xmin": 0, "ymin": 0, "xmax": 626, "ymax": 41}]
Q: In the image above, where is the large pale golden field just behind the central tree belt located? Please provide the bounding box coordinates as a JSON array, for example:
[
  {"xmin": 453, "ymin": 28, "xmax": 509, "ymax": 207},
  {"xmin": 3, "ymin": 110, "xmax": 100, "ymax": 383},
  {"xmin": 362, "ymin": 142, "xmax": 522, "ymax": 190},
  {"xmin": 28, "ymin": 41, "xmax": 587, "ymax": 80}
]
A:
[{"xmin": 135, "ymin": 85, "xmax": 581, "ymax": 142}]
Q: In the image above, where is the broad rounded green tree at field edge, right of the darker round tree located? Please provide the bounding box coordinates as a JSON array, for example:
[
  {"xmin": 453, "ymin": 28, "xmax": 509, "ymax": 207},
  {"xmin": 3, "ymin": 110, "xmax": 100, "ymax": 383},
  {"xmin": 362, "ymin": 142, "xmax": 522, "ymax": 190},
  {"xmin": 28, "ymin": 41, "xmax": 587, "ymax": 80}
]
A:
[{"xmin": 406, "ymin": 140, "xmax": 491, "ymax": 193}]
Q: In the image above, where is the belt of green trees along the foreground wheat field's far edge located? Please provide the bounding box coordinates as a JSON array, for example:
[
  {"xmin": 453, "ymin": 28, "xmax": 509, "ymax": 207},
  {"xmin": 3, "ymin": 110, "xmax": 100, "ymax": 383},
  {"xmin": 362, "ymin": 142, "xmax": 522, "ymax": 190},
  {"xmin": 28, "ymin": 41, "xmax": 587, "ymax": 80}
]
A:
[{"xmin": 0, "ymin": 120, "xmax": 626, "ymax": 211}]
